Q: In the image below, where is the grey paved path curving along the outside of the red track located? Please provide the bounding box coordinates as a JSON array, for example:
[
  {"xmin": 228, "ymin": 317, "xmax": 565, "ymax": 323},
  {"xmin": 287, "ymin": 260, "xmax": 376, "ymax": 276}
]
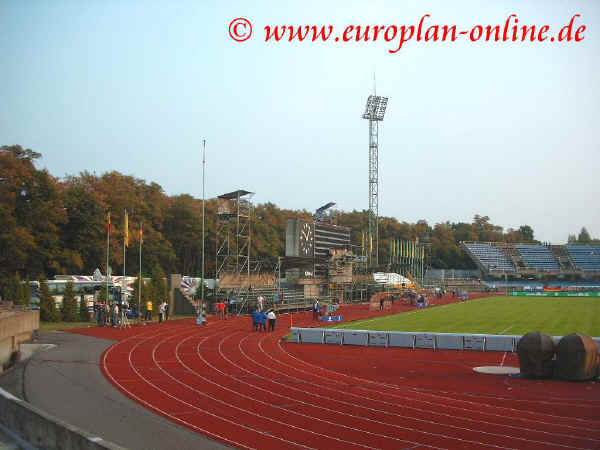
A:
[{"xmin": 0, "ymin": 332, "xmax": 229, "ymax": 450}]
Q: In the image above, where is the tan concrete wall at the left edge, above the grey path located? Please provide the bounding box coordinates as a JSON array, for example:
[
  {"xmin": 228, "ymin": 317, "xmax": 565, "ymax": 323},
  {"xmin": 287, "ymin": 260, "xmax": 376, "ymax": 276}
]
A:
[{"xmin": 0, "ymin": 311, "xmax": 40, "ymax": 372}]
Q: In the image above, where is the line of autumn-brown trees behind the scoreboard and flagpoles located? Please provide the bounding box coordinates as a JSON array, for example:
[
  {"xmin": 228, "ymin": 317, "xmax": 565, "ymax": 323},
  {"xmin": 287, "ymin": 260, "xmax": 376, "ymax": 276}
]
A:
[{"xmin": 0, "ymin": 145, "xmax": 598, "ymax": 298}]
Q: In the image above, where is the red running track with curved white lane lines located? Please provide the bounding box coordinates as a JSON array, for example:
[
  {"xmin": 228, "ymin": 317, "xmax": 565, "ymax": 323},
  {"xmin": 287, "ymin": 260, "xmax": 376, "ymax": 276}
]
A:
[{"xmin": 74, "ymin": 304, "xmax": 600, "ymax": 449}]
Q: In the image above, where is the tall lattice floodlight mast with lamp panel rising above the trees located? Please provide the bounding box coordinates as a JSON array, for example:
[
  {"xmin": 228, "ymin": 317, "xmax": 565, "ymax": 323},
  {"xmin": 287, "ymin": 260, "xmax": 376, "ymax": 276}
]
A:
[{"xmin": 363, "ymin": 95, "xmax": 388, "ymax": 267}]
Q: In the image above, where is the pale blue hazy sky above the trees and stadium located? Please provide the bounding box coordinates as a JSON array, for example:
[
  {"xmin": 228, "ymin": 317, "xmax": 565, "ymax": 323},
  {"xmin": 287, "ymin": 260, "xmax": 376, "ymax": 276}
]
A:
[{"xmin": 0, "ymin": 0, "xmax": 600, "ymax": 244}]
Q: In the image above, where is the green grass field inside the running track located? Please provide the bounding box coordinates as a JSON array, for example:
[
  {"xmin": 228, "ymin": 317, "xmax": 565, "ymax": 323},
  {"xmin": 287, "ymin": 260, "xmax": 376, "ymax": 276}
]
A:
[{"xmin": 332, "ymin": 297, "xmax": 600, "ymax": 337}]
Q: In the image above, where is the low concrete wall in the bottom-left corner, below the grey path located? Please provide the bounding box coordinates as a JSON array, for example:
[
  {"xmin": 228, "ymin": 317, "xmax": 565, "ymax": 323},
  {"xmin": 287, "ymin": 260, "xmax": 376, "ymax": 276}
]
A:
[{"xmin": 0, "ymin": 389, "xmax": 125, "ymax": 450}]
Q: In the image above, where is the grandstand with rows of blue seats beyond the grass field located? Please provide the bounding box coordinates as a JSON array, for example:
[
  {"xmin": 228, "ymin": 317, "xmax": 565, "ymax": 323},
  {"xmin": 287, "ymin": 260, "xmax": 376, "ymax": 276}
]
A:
[{"xmin": 460, "ymin": 242, "xmax": 600, "ymax": 280}]
